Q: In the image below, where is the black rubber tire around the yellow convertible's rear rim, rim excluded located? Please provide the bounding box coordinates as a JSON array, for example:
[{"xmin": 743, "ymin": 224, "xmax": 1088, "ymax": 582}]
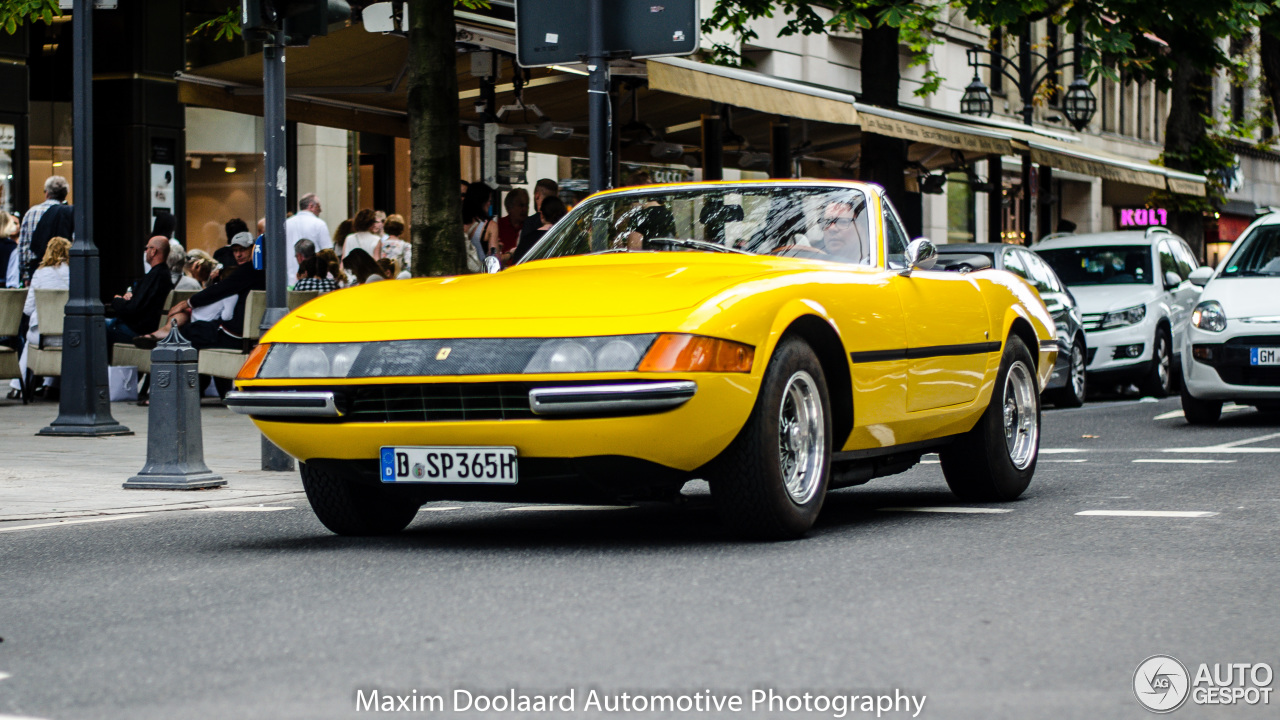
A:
[{"xmin": 938, "ymin": 336, "xmax": 1041, "ymax": 502}]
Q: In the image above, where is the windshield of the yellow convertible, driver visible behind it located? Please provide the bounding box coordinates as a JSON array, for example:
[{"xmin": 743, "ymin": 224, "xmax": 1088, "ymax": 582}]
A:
[{"xmin": 524, "ymin": 184, "xmax": 876, "ymax": 265}]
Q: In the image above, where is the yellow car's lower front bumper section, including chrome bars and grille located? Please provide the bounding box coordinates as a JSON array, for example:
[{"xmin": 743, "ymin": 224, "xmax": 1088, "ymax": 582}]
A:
[{"xmin": 235, "ymin": 373, "xmax": 759, "ymax": 471}]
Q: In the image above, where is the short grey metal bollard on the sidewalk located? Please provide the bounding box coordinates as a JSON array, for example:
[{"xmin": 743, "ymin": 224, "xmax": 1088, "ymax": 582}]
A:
[{"xmin": 124, "ymin": 323, "xmax": 227, "ymax": 489}]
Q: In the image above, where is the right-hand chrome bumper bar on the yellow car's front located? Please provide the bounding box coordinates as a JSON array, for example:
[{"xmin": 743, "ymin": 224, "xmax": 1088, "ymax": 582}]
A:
[{"xmin": 529, "ymin": 380, "xmax": 698, "ymax": 415}]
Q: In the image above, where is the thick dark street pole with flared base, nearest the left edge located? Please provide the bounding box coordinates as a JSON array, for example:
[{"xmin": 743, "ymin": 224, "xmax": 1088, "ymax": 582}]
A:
[{"xmin": 37, "ymin": 0, "xmax": 133, "ymax": 437}]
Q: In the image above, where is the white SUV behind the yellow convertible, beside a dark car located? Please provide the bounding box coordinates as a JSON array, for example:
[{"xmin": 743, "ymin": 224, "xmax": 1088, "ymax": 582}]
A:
[{"xmin": 1032, "ymin": 228, "xmax": 1201, "ymax": 397}]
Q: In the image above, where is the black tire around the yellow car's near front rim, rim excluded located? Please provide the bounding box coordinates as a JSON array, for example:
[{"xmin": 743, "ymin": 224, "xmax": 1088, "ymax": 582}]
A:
[{"xmin": 708, "ymin": 337, "xmax": 831, "ymax": 539}]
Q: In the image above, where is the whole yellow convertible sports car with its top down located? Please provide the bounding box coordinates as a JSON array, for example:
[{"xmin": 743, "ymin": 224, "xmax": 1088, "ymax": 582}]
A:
[{"xmin": 227, "ymin": 181, "xmax": 1057, "ymax": 538}]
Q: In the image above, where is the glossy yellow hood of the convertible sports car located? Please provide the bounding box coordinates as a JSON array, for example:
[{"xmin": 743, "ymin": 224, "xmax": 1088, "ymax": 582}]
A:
[{"xmin": 294, "ymin": 252, "xmax": 793, "ymax": 323}]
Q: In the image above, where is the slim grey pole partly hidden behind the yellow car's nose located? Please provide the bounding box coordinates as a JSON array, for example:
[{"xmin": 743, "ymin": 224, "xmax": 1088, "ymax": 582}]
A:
[{"xmin": 261, "ymin": 29, "xmax": 293, "ymax": 470}]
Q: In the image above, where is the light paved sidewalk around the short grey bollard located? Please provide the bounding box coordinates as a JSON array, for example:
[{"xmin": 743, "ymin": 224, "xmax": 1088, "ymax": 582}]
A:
[{"xmin": 0, "ymin": 398, "xmax": 302, "ymax": 523}]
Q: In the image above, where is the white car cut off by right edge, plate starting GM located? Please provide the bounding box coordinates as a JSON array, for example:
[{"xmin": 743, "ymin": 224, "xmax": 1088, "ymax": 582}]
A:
[{"xmin": 1183, "ymin": 213, "xmax": 1280, "ymax": 424}]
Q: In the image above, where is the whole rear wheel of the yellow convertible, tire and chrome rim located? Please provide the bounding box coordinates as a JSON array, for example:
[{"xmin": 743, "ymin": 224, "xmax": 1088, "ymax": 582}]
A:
[{"xmin": 938, "ymin": 336, "xmax": 1041, "ymax": 502}]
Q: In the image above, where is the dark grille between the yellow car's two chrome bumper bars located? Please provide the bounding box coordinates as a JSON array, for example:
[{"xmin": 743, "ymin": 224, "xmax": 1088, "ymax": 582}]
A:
[{"xmin": 342, "ymin": 383, "xmax": 547, "ymax": 423}]
